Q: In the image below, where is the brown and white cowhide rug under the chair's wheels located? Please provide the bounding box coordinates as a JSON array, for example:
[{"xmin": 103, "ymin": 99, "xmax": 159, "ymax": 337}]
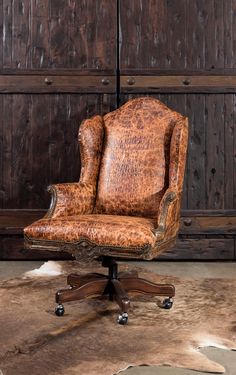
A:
[{"xmin": 0, "ymin": 262, "xmax": 236, "ymax": 375}]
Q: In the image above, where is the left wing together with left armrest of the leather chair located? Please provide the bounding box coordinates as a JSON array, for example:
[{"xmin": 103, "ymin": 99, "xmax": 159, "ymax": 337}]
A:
[{"xmin": 46, "ymin": 116, "xmax": 104, "ymax": 218}]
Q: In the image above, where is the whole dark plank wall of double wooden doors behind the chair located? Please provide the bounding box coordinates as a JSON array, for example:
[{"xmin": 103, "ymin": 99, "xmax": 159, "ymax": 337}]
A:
[{"xmin": 0, "ymin": 0, "xmax": 236, "ymax": 259}]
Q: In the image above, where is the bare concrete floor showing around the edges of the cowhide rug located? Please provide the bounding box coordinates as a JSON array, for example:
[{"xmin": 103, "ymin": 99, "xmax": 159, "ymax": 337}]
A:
[{"xmin": 0, "ymin": 261, "xmax": 236, "ymax": 375}]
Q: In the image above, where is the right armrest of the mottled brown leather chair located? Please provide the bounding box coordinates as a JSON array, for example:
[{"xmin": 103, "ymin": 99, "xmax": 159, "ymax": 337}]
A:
[{"xmin": 155, "ymin": 188, "xmax": 181, "ymax": 240}]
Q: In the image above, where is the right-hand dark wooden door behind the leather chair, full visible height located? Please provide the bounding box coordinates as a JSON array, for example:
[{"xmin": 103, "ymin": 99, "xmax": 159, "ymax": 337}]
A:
[{"xmin": 120, "ymin": 0, "xmax": 236, "ymax": 259}]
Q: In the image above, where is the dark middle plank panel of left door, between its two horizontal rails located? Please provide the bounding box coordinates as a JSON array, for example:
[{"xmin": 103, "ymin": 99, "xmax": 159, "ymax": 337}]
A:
[{"xmin": 0, "ymin": 94, "xmax": 116, "ymax": 208}]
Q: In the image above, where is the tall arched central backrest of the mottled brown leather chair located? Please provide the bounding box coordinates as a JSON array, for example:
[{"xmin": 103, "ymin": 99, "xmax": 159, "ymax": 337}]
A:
[{"xmin": 95, "ymin": 97, "xmax": 185, "ymax": 217}]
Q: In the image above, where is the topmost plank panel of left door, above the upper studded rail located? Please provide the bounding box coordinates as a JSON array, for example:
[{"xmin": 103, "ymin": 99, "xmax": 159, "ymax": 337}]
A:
[{"xmin": 0, "ymin": 0, "xmax": 116, "ymax": 71}]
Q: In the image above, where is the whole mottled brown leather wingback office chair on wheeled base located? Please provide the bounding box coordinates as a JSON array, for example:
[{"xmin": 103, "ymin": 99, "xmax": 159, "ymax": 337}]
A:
[{"xmin": 25, "ymin": 97, "xmax": 188, "ymax": 324}]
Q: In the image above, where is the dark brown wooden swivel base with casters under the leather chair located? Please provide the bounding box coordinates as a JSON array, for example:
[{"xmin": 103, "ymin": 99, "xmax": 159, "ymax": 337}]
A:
[{"xmin": 55, "ymin": 257, "xmax": 175, "ymax": 325}]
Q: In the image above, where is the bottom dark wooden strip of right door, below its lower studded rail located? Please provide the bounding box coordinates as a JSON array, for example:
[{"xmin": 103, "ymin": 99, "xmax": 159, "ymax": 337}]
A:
[{"xmin": 158, "ymin": 238, "xmax": 234, "ymax": 260}]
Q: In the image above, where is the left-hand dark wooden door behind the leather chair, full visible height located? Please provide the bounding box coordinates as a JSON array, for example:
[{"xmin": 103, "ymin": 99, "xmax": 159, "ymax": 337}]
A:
[{"xmin": 0, "ymin": 0, "xmax": 117, "ymax": 259}]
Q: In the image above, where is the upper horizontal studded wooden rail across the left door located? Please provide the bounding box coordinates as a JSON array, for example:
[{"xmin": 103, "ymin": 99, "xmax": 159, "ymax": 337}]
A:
[{"xmin": 0, "ymin": 75, "xmax": 116, "ymax": 94}]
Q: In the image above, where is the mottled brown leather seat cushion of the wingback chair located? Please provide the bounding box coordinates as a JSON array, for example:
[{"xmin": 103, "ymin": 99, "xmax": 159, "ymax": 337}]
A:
[{"xmin": 24, "ymin": 215, "xmax": 156, "ymax": 248}]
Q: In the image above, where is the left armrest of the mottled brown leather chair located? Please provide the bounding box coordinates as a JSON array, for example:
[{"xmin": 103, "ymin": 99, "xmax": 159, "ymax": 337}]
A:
[{"xmin": 45, "ymin": 183, "xmax": 95, "ymax": 218}]
